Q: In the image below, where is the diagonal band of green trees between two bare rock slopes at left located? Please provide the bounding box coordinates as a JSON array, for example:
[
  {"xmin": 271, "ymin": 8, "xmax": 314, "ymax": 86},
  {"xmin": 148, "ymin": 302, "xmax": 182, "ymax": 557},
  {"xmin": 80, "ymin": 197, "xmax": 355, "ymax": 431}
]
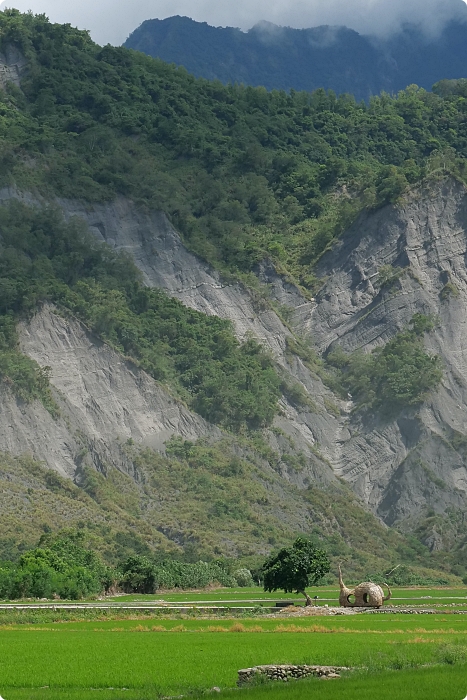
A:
[{"xmin": 0, "ymin": 201, "xmax": 280, "ymax": 432}]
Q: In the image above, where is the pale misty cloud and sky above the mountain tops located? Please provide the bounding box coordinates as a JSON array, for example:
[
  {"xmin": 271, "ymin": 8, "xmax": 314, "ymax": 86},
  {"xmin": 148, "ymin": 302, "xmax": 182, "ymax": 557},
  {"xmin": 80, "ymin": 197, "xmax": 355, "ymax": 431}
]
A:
[{"xmin": 0, "ymin": 0, "xmax": 467, "ymax": 45}]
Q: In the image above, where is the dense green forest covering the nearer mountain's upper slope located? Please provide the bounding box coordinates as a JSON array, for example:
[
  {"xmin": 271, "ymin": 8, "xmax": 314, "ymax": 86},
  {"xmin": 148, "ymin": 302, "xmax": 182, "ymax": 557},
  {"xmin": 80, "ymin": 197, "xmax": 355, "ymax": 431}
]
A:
[{"xmin": 0, "ymin": 10, "xmax": 467, "ymax": 288}]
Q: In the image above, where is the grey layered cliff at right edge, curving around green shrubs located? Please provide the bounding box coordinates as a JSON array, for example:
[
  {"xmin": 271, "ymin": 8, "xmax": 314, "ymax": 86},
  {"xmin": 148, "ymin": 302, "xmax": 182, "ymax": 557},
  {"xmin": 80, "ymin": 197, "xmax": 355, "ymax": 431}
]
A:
[{"xmin": 302, "ymin": 180, "xmax": 467, "ymax": 524}]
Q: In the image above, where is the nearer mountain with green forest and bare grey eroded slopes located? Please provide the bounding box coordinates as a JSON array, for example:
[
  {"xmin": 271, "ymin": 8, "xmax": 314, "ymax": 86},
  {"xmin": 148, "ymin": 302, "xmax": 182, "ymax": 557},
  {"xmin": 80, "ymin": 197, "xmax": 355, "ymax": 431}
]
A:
[{"xmin": 0, "ymin": 10, "xmax": 467, "ymax": 577}]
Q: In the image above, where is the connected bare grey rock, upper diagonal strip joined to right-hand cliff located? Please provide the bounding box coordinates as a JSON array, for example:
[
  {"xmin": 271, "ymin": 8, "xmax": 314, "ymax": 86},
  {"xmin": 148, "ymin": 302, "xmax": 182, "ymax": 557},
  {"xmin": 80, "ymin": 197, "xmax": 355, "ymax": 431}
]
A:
[{"xmin": 57, "ymin": 180, "xmax": 467, "ymax": 523}]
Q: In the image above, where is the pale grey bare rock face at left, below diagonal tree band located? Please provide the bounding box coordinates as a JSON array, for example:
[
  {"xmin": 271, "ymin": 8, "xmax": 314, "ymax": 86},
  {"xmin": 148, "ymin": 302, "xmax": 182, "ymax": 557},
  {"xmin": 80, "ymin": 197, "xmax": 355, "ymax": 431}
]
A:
[{"xmin": 0, "ymin": 307, "xmax": 221, "ymax": 478}]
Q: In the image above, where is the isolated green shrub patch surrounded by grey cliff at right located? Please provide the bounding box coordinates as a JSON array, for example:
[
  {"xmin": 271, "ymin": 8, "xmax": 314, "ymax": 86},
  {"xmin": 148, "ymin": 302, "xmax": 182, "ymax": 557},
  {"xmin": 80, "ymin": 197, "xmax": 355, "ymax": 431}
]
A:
[{"xmin": 327, "ymin": 314, "xmax": 443, "ymax": 411}]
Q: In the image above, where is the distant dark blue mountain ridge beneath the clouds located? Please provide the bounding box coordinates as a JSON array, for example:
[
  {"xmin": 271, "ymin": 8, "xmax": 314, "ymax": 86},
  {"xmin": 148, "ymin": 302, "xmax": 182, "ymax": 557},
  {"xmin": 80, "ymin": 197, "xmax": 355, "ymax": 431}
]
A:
[{"xmin": 124, "ymin": 14, "xmax": 467, "ymax": 100}]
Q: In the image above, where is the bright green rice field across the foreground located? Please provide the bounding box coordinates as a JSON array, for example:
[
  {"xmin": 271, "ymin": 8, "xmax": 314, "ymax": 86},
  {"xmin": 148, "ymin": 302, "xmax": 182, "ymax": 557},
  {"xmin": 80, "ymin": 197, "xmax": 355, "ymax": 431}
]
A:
[{"xmin": 0, "ymin": 589, "xmax": 467, "ymax": 700}]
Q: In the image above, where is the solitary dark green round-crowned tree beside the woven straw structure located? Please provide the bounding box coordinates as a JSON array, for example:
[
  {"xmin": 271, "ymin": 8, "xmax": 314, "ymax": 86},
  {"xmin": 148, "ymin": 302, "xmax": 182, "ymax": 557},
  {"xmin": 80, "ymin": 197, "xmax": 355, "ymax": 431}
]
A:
[{"xmin": 263, "ymin": 537, "xmax": 331, "ymax": 605}]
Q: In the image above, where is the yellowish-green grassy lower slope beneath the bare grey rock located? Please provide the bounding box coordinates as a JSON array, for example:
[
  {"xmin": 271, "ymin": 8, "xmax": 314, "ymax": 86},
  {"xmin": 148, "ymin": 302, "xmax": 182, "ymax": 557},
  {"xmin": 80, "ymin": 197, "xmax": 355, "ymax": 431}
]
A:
[{"xmin": 0, "ymin": 438, "xmax": 448, "ymax": 576}]
